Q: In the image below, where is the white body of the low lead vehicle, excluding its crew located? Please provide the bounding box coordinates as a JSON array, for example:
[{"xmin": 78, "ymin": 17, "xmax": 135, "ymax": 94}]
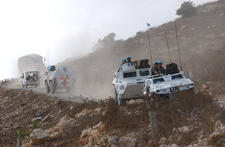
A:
[{"xmin": 143, "ymin": 72, "xmax": 194, "ymax": 97}]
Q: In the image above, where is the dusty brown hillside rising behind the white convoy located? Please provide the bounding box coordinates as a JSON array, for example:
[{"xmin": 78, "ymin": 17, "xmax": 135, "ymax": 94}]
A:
[{"xmin": 61, "ymin": 0, "xmax": 225, "ymax": 98}]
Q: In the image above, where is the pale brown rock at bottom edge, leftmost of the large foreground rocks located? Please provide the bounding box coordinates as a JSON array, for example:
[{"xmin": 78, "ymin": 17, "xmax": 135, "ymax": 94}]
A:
[{"xmin": 30, "ymin": 129, "xmax": 50, "ymax": 145}]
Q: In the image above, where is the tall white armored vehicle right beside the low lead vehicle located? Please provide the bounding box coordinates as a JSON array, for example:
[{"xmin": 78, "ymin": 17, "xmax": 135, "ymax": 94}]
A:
[{"xmin": 112, "ymin": 59, "xmax": 151, "ymax": 105}]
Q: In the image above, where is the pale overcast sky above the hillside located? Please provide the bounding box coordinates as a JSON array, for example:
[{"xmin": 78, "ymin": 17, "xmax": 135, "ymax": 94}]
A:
[{"xmin": 0, "ymin": 0, "xmax": 216, "ymax": 79}]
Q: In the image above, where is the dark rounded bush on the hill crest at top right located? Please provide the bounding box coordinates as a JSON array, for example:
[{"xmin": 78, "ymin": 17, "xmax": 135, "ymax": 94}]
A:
[{"xmin": 177, "ymin": 1, "xmax": 196, "ymax": 17}]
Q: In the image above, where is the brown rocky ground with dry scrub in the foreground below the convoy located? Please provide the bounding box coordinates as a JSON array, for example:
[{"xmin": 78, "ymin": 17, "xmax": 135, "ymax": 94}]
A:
[{"xmin": 0, "ymin": 82, "xmax": 225, "ymax": 147}]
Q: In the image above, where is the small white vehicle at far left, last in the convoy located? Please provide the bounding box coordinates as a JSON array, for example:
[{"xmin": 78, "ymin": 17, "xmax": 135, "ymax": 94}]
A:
[{"xmin": 20, "ymin": 71, "xmax": 40, "ymax": 88}]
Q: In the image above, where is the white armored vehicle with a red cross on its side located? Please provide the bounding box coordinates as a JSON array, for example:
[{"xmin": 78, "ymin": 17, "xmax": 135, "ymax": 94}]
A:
[{"xmin": 45, "ymin": 66, "xmax": 74, "ymax": 94}]
